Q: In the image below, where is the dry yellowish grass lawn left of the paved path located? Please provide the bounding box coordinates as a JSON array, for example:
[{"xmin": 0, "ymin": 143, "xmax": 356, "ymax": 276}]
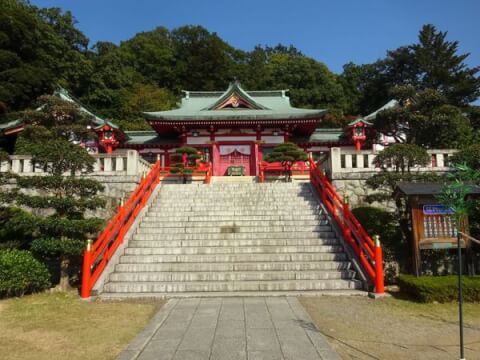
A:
[{"xmin": 0, "ymin": 293, "xmax": 162, "ymax": 360}]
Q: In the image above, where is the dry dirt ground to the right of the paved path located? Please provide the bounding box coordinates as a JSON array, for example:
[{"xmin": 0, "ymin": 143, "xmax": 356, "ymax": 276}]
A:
[{"xmin": 300, "ymin": 296, "xmax": 480, "ymax": 360}]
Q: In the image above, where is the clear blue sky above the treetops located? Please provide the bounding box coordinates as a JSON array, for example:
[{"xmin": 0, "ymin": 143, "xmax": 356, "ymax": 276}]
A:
[{"xmin": 31, "ymin": 0, "xmax": 480, "ymax": 72}]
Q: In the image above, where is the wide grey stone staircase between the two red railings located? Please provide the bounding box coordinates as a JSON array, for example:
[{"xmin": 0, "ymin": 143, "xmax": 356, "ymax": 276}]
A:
[{"xmin": 102, "ymin": 183, "xmax": 362, "ymax": 297}]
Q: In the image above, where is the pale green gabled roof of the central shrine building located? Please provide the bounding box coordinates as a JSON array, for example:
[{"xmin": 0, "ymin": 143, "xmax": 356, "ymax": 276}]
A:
[{"xmin": 143, "ymin": 82, "xmax": 327, "ymax": 122}]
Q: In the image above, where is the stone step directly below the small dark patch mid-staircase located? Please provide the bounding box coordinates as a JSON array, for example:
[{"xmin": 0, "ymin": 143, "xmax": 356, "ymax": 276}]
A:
[{"xmin": 129, "ymin": 231, "xmax": 336, "ymax": 241}]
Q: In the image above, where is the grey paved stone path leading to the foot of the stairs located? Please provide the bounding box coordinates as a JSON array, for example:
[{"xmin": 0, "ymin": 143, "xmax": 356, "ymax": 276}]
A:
[{"xmin": 117, "ymin": 297, "xmax": 339, "ymax": 360}]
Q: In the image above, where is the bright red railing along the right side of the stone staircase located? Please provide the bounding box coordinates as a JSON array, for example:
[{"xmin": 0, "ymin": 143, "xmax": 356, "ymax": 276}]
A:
[{"xmin": 310, "ymin": 159, "xmax": 384, "ymax": 294}]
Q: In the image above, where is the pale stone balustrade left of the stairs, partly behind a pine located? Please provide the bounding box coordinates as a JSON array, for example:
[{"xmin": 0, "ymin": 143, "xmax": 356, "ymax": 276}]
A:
[{"xmin": 0, "ymin": 149, "xmax": 151, "ymax": 176}]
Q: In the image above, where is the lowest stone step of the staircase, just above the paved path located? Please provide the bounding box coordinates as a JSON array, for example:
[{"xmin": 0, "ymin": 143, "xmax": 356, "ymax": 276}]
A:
[{"xmin": 105, "ymin": 279, "xmax": 361, "ymax": 293}]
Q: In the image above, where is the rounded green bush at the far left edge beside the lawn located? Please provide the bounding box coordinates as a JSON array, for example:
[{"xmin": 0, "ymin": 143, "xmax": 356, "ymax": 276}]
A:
[{"xmin": 0, "ymin": 250, "xmax": 50, "ymax": 297}]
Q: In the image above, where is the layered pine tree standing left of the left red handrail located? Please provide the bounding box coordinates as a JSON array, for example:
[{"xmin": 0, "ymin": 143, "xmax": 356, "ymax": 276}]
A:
[{"xmin": 2, "ymin": 96, "xmax": 105, "ymax": 290}]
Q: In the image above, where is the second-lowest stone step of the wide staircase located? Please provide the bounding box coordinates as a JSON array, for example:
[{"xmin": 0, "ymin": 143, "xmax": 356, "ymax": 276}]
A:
[{"xmin": 109, "ymin": 270, "xmax": 354, "ymax": 282}]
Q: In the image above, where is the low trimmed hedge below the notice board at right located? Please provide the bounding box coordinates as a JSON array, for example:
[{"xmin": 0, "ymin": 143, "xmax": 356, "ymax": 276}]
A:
[{"xmin": 398, "ymin": 275, "xmax": 480, "ymax": 303}]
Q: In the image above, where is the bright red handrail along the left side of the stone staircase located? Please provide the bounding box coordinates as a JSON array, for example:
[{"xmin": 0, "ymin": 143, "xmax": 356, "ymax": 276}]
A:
[{"xmin": 80, "ymin": 160, "xmax": 162, "ymax": 298}]
